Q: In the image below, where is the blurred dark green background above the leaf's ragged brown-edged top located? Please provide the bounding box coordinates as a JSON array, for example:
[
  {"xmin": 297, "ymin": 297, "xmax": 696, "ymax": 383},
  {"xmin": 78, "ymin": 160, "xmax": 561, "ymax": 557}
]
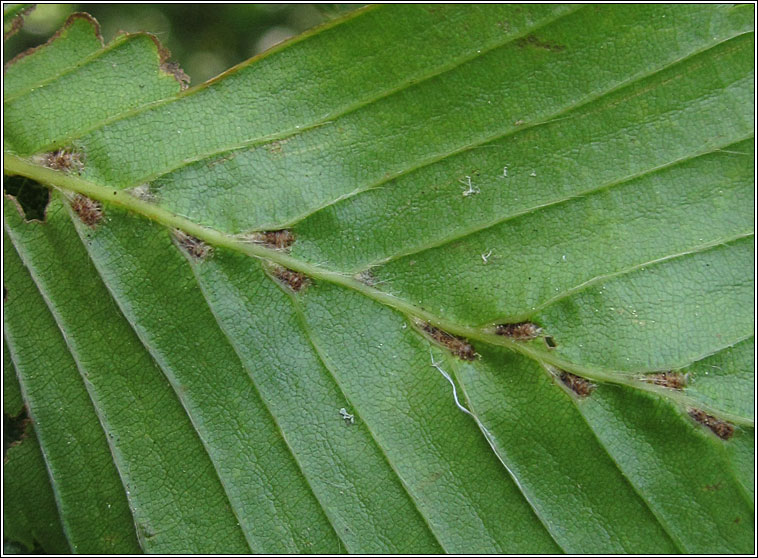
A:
[{"xmin": 3, "ymin": 4, "xmax": 363, "ymax": 85}]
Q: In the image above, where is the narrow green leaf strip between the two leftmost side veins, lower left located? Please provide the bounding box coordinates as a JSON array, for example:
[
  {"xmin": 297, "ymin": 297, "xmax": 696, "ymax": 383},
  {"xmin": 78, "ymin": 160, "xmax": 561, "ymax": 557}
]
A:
[{"xmin": 3, "ymin": 223, "xmax": 139, "ymax": 552}]
